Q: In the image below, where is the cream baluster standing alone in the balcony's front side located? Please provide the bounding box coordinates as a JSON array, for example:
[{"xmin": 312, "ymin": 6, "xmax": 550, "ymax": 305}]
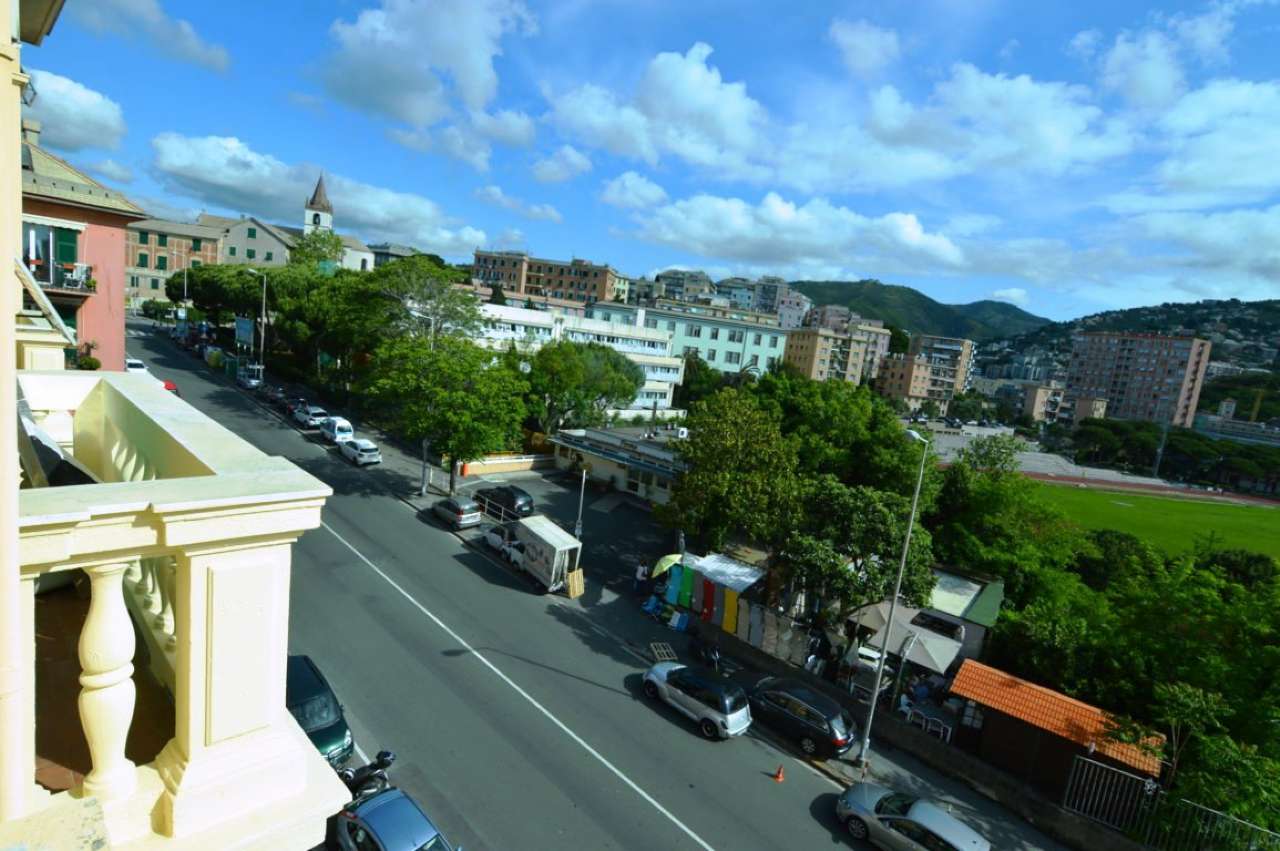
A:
[{"xmin": 79, "ymin": 563, "xmax": 137, "ymax": 801}]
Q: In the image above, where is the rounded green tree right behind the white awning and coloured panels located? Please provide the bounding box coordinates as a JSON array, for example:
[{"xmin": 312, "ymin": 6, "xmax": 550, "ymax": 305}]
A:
[{"xmin": 655, "ymin": 389, "xmax": 799, "ymax": 552}]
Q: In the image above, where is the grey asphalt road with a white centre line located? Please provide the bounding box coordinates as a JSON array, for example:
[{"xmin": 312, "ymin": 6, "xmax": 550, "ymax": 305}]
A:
[{"xmin": 128, "ymin": 322, "xmax": 849, "ymax": 851}]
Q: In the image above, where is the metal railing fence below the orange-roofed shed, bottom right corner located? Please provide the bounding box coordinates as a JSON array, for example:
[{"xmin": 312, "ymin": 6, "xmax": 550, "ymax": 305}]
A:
[{"xmin": 1062, "ymin": 756, "xmax": 1280, "ymax": 851}]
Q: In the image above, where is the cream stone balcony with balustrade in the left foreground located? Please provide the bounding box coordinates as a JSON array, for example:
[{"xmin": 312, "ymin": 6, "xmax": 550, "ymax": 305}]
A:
[{"xmin": 0, "ymin": 372, "xmax": 348, "ymax": 848}]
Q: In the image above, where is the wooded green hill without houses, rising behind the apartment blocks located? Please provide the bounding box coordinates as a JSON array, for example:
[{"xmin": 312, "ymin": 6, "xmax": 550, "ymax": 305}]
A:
[{"xmin": 791, "ymin": 280, "xmax": 1050, "ymax": 342}]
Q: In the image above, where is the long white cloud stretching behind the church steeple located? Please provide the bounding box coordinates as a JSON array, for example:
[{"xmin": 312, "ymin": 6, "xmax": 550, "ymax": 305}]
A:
[{"xmin": 151, "ymin": 133, "xmax": 485, "ymax": 257}]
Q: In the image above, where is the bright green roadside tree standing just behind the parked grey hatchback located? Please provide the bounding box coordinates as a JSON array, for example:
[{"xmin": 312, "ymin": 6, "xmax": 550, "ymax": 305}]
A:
[{"xmin": 370, "ymin": 337, "xmax": 527, "ymax": 493}]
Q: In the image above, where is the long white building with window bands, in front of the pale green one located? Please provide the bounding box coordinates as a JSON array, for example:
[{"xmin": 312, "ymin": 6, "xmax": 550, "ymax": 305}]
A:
[{"xmin": 476, "ymin": 305, "xmax": 685, "ymax": 412}]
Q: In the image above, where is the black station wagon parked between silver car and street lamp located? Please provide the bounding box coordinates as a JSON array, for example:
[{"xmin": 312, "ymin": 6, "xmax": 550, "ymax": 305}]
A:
[{"xmin": 750, "ymin": 677, "xmax": 856, "ymax": 759}]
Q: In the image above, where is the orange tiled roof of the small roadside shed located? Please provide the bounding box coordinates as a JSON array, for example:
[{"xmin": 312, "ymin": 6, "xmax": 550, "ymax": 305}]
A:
[{"xmin": 951, "ymin": 659, "xmax": 1165, "ymax": 777}]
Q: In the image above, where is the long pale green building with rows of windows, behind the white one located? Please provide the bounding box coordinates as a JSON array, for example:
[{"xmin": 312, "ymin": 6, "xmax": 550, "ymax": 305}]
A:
[{"xmin": 588, "ymin": 299, "xmax": 787, "ymax": 374}]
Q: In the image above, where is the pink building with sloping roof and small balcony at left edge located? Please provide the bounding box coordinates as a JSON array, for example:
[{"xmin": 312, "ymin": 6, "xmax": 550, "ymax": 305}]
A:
[{"xmin": 20, "ymin": 117, "xmax": 147, "ymax": 370}]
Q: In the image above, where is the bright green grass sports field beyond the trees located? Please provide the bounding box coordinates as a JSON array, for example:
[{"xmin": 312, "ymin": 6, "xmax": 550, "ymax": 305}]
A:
[{"xmin": 1042, "ymin": 485, "xmax": 1280, "ymax": 558}]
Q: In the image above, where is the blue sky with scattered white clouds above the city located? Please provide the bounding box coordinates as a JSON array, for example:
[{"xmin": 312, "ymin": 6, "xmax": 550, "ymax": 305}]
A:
[{"xmin": 23, "ymin": 0, "xmax": 1280, "ymax": 319}]
